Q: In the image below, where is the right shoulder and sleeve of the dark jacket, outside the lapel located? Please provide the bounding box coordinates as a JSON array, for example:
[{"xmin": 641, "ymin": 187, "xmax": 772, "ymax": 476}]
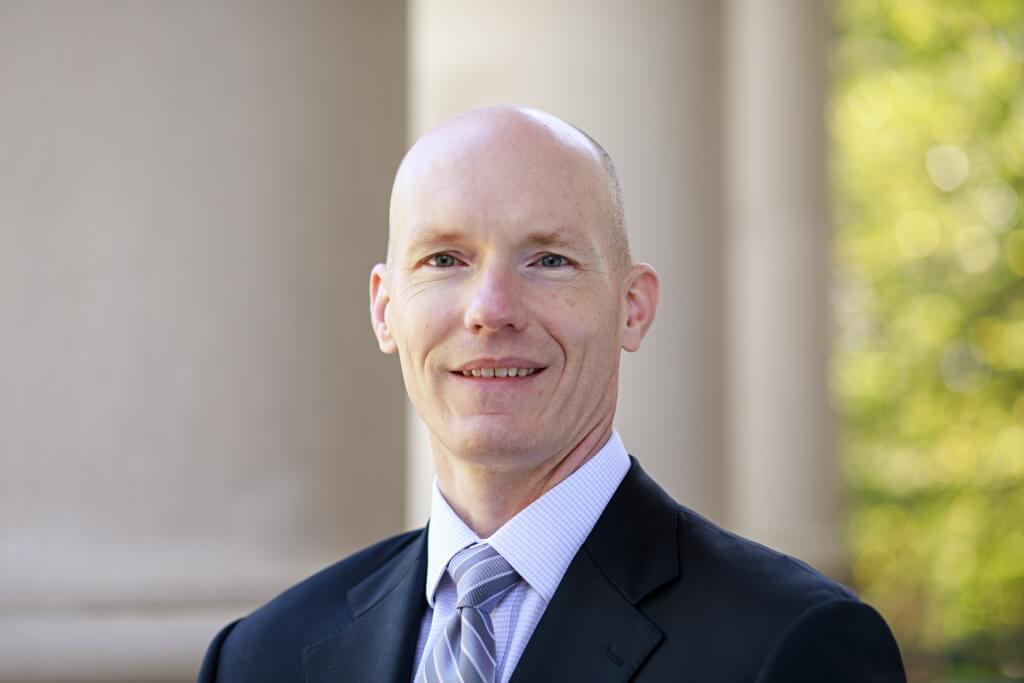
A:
[{"xmin": 645, "ymin": 504, "xmax": 903, "ymax": 683}]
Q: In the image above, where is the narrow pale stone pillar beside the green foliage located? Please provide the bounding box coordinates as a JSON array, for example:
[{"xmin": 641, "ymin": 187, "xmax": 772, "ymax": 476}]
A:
[{"xmin": 724, "ymin": 0, "xmax": 842, "ymax": 574}]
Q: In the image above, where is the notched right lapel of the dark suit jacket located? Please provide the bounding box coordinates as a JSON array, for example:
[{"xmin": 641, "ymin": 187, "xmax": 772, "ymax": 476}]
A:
[{"xmin": 511, "ymin": 460, "xmax": 680, "ymax": 683}]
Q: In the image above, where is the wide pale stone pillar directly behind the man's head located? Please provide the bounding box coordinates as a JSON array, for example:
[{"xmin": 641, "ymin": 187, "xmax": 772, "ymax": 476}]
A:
[{"xmin": 408, "ymin": 0, "xmax": 724, "ymax": 525}]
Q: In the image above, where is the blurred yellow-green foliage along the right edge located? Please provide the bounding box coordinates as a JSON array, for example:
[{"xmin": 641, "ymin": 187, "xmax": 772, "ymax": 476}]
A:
[{"xmin": 829, "ymin": 0, "xmax": 1024, "ymax": 681}]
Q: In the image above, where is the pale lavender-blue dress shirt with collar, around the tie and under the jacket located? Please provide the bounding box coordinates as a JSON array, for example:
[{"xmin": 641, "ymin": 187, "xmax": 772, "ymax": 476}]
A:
[{"xmin": 413, "ymin": 430, "xmax": 630, "ymax": 683}]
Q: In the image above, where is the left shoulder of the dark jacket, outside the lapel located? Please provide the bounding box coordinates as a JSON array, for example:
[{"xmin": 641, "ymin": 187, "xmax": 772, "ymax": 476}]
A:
[{"xmin": 199, "ymin": 529, "xmax": 423, "ymax": 683}]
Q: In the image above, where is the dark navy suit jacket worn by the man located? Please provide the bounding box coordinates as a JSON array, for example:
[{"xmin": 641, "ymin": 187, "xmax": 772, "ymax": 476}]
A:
[{"xmin": 199, "ymin": 460, "xmax": 905, "ymax": 683}]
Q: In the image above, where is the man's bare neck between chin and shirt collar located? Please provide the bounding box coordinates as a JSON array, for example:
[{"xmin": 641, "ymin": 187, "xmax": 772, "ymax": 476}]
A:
[{"xmin": 433, "ymin": 416, "xmax": 611, "ymax": 539}]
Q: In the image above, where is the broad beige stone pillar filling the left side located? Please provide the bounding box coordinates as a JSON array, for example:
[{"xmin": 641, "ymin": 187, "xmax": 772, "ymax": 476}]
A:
[{"xmin": 0, "ymin": 0, "xmax": 406, "ymax": 681}]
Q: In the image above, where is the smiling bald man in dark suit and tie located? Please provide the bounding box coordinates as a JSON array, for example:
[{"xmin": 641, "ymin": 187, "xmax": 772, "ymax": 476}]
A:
[{"xmin": 200, "ymin": 106, "xmax": 904, "ymax": 683}]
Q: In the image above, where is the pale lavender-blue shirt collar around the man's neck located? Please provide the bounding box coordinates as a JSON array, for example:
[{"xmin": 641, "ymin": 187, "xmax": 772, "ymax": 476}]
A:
[{"xmin": 426, "ymin": 430, "xmax": 630, "ymax": 607}]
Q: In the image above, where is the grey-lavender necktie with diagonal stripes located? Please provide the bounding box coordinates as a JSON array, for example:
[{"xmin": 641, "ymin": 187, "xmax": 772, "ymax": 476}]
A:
[{"xmin": 416, "ymin": 544, "xmax": 519, "ymax": 683}]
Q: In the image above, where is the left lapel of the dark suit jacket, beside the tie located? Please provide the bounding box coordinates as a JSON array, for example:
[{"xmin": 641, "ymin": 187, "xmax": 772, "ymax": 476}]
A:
[{"xmin": 303, "ymin": 530, "xmax": 427, "ymax": 683}]
